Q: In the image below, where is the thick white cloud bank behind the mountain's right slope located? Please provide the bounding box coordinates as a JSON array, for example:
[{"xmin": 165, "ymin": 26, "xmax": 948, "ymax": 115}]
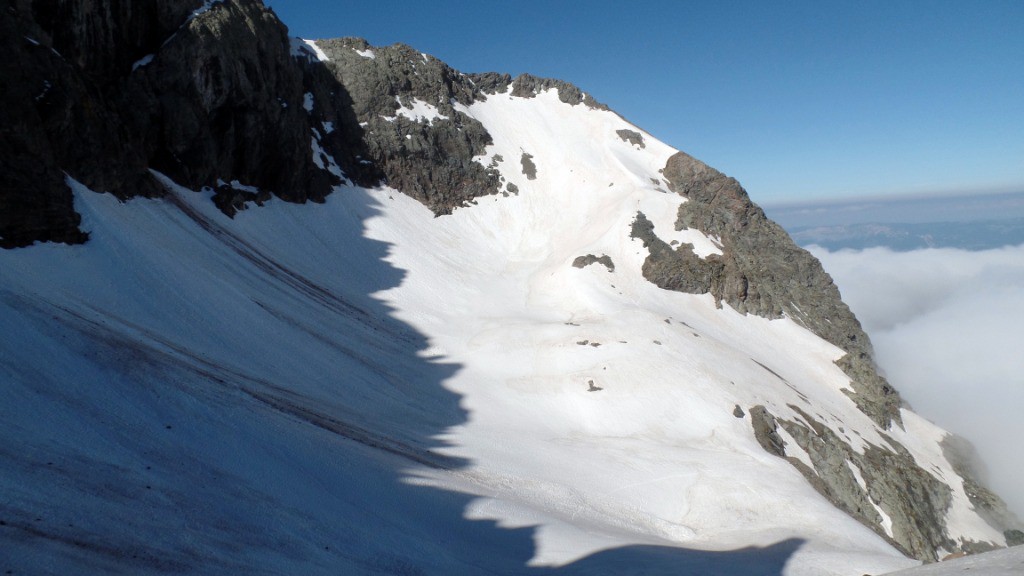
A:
[{"xmin": 811, "ymin": 241, "xmax": 1024, "ymax": 518}]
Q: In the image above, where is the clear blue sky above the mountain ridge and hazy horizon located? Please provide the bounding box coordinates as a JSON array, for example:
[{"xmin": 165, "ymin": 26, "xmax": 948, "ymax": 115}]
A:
[{"xmin": 267, "ymin": 0, "xmax": 1024, "ymax": 204}]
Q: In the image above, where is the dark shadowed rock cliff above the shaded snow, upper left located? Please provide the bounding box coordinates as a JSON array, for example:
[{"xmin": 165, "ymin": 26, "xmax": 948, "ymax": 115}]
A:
[{"xmin": 0, "ymin": 0, "xmax": 381, "ymax": 242}]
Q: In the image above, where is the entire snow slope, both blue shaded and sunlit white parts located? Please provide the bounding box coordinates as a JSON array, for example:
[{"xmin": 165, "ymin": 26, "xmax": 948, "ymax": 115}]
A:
[{"xmin": 0, "ymin": 84, "xmax": 1001, "ymax": 575}]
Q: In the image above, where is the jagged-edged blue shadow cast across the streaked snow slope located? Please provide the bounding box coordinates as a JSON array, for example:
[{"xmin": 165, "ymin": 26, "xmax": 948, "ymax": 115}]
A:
[{"xmin": 0, "ymin": 180, "xmax": 802, "ymax": 576}]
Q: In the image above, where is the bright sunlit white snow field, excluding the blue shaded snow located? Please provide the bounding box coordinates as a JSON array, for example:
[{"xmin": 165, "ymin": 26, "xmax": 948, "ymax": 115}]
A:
[{"xmin": 368, "ymin": 85, "xmax": 929, "ymax": 573}]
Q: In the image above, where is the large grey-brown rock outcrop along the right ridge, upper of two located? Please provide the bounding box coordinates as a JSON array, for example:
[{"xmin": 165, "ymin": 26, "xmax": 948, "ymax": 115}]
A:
[{"xmin": 633, "ymin": 153, "xmax": 900, "ymax": 428}]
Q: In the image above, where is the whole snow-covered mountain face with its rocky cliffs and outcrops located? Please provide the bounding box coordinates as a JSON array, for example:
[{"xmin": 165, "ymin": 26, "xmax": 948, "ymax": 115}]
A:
[{"xmin": 0, "ymin": 0, "xmax": 1020, "ymax": 575}]
